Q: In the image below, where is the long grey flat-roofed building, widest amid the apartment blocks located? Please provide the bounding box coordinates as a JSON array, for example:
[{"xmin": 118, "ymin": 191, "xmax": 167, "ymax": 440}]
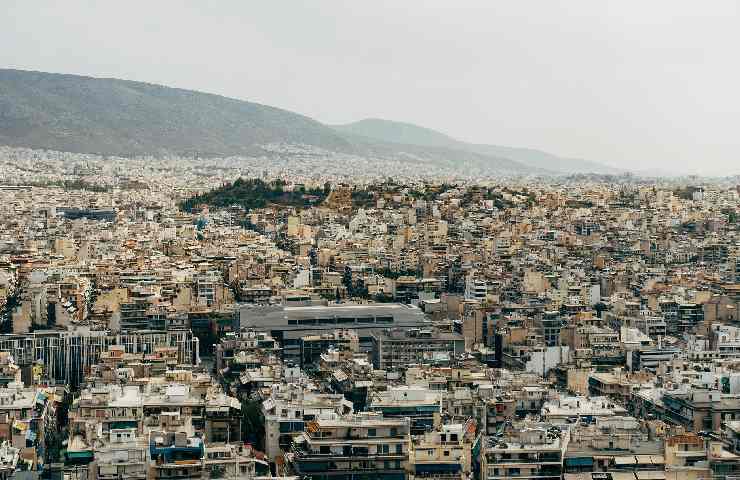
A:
[{"xmin": 238, "ymin": 303, "xmax": 431, "ymax": 363}]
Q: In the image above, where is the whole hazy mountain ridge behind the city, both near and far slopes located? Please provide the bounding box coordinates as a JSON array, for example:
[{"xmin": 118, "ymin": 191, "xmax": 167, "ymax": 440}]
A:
[{"xmin": 0, "ymin": 69, "xmax": 603, "ymax": 176}]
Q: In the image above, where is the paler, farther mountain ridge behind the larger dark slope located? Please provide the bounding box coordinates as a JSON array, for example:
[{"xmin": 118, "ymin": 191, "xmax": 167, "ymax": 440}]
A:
[{"xmin": 333, "ymin": 118, "xmax": 624, "ymax": 174}]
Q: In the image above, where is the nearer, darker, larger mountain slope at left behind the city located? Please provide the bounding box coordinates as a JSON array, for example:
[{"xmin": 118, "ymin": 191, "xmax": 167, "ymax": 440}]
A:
[{"xmin": 0, "ymin": 69, "xmax": 349, "ymax": 155}]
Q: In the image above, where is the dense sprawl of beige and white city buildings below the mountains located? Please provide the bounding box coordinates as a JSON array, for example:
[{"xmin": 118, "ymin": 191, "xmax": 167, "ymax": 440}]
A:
[{"xmin": 0, "ymin": 147, "xmax": 740, "ymax": 480}]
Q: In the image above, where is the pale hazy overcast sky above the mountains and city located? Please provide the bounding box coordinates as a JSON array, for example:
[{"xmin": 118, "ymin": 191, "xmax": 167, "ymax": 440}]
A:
[{"xmin": 0, "ymin": 0, "xmax": 740, "ymax": 173}]
